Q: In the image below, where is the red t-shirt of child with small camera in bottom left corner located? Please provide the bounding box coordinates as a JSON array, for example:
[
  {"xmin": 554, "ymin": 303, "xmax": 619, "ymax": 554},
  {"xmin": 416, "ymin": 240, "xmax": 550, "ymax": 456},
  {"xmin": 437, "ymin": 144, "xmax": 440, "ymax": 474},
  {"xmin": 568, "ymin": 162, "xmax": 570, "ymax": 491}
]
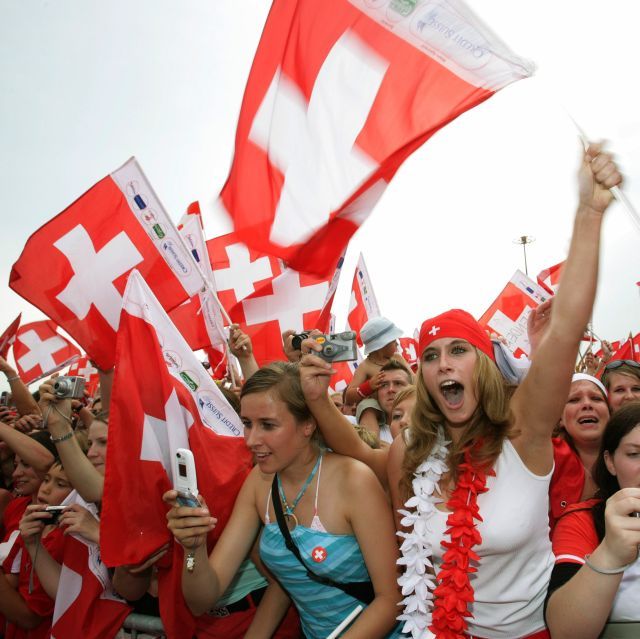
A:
[{"xmin": 5, "ymin": 528, "xmax": 64, "ymax": 639}]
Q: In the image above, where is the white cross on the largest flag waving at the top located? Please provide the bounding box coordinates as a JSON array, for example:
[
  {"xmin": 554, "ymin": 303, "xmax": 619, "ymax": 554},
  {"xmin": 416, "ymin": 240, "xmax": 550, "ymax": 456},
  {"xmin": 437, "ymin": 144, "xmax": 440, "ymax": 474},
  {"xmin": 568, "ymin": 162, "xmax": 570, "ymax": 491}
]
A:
[{"xmin": 249, "ymin": 31, "xmax": 388, "ymax": 246}]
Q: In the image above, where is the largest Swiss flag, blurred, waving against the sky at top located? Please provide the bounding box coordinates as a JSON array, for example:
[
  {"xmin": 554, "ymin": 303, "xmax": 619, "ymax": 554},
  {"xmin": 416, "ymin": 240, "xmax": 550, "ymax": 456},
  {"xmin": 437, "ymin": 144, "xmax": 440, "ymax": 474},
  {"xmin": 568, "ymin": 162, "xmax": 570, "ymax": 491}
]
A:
[{"xmin": 221, "ymin": 0, "xmax": 533, "ymax": 275}]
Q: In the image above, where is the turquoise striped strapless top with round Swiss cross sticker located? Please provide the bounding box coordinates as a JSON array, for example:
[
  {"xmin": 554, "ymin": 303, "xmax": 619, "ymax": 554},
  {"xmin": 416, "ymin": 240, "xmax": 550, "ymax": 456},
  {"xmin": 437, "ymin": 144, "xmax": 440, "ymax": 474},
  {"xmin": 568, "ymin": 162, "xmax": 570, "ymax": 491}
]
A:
[{"xmin": 260, "ymin": 522, "xmax": 402, "ymax": 639}]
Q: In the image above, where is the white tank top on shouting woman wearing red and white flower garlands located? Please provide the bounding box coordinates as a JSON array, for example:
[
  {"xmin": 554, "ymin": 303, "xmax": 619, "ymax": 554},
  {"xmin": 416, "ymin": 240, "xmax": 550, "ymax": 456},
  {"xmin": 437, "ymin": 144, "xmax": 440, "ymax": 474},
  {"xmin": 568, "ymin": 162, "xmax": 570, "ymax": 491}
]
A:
[{"xmin": 430, "ymin": 440, "xmax": 554, "ymax": 639}]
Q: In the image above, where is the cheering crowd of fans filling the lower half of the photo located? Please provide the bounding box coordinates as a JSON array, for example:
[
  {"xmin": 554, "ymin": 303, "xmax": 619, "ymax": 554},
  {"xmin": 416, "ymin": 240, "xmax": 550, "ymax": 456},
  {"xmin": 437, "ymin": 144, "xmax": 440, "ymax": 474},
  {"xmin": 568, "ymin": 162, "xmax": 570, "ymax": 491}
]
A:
[{"xmin": 0, "ymin": 145, "xmax": 640, "ymax": 639}]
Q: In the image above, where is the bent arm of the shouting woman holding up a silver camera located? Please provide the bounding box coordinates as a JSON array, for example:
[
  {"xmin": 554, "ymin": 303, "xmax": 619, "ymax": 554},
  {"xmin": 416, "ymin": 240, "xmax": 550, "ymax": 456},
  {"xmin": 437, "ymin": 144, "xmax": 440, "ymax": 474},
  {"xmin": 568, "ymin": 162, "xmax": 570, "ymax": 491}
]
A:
[{"xmin": 300, "ymin": 352, "xmax": 388, "ymax": 486}]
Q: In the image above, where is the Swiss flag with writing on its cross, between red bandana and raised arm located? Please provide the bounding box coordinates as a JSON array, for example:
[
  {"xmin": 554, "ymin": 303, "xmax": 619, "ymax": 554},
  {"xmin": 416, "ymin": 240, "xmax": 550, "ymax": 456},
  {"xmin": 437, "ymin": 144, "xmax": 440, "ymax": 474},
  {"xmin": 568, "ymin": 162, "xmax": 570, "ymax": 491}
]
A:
[{"xmin": 478, "ymin": 271, "xmax": 551, "ymax": 357}]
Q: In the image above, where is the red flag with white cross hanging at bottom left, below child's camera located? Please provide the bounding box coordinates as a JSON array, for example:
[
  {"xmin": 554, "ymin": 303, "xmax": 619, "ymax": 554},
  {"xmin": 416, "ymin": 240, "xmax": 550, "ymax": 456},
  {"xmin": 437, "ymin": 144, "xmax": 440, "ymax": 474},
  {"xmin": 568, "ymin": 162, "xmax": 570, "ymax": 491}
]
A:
[{"xmin": 51, "ymin": 491, "xmax": 132, "ymax": 639}]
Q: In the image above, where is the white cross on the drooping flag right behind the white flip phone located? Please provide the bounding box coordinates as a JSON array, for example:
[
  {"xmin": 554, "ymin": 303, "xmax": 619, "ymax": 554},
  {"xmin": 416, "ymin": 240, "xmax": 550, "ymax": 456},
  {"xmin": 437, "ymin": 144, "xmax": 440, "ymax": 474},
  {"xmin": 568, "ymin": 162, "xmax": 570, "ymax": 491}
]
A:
[{"xmin": 140, "ymin": 390, "xmax": 193, "ymax": 483}]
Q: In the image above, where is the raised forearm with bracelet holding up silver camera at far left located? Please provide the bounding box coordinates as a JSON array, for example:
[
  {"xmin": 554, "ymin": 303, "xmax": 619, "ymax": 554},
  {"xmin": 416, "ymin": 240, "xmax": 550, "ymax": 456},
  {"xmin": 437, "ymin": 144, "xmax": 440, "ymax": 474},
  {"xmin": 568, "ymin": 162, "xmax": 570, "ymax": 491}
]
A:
[{"xmin": 40, "ymin": 380, "xmax": 104, "ymax": 502}]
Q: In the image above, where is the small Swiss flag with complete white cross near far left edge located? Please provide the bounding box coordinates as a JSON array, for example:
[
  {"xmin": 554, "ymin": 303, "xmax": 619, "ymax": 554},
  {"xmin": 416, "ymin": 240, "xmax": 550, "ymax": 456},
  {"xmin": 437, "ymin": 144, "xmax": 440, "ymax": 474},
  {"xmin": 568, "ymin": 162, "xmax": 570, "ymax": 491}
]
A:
[{"xmin": 13, "ymin": 320, "xmax": 80, "ymax": 384}]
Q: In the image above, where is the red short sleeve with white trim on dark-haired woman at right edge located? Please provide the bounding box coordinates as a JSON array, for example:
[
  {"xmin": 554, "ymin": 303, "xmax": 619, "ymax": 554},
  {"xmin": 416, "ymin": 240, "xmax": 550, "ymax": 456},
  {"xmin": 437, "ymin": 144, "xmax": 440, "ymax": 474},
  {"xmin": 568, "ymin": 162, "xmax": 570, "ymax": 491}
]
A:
[{"xmin": 551, "ymin": 499, "xmax": 600, "ymax": 564}]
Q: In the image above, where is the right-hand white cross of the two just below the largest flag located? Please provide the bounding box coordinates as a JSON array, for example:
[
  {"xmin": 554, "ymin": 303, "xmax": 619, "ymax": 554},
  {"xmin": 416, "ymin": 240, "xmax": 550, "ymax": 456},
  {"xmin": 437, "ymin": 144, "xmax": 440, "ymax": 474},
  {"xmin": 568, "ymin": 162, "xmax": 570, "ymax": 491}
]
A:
[{"xmin": 242, "ymin": 270, "xmax": 329, "ymax": 333}]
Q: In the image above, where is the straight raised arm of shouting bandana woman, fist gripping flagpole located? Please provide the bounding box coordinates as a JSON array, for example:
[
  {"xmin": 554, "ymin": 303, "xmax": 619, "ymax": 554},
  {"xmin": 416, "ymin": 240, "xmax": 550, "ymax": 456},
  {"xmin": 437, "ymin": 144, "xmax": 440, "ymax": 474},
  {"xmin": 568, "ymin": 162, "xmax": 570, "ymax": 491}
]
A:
[{"xmin": 511, "ymin": 145, "xmax": 622, "ymax": 474}]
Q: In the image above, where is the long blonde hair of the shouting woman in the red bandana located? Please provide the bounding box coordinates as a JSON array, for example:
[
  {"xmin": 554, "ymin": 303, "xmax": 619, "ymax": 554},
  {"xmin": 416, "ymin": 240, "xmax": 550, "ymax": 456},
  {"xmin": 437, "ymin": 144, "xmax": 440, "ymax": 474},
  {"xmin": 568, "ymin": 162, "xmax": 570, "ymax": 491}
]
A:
[{"xmin": 400, "ymin": 348, "xmax": 514, "ymax": 500}]
